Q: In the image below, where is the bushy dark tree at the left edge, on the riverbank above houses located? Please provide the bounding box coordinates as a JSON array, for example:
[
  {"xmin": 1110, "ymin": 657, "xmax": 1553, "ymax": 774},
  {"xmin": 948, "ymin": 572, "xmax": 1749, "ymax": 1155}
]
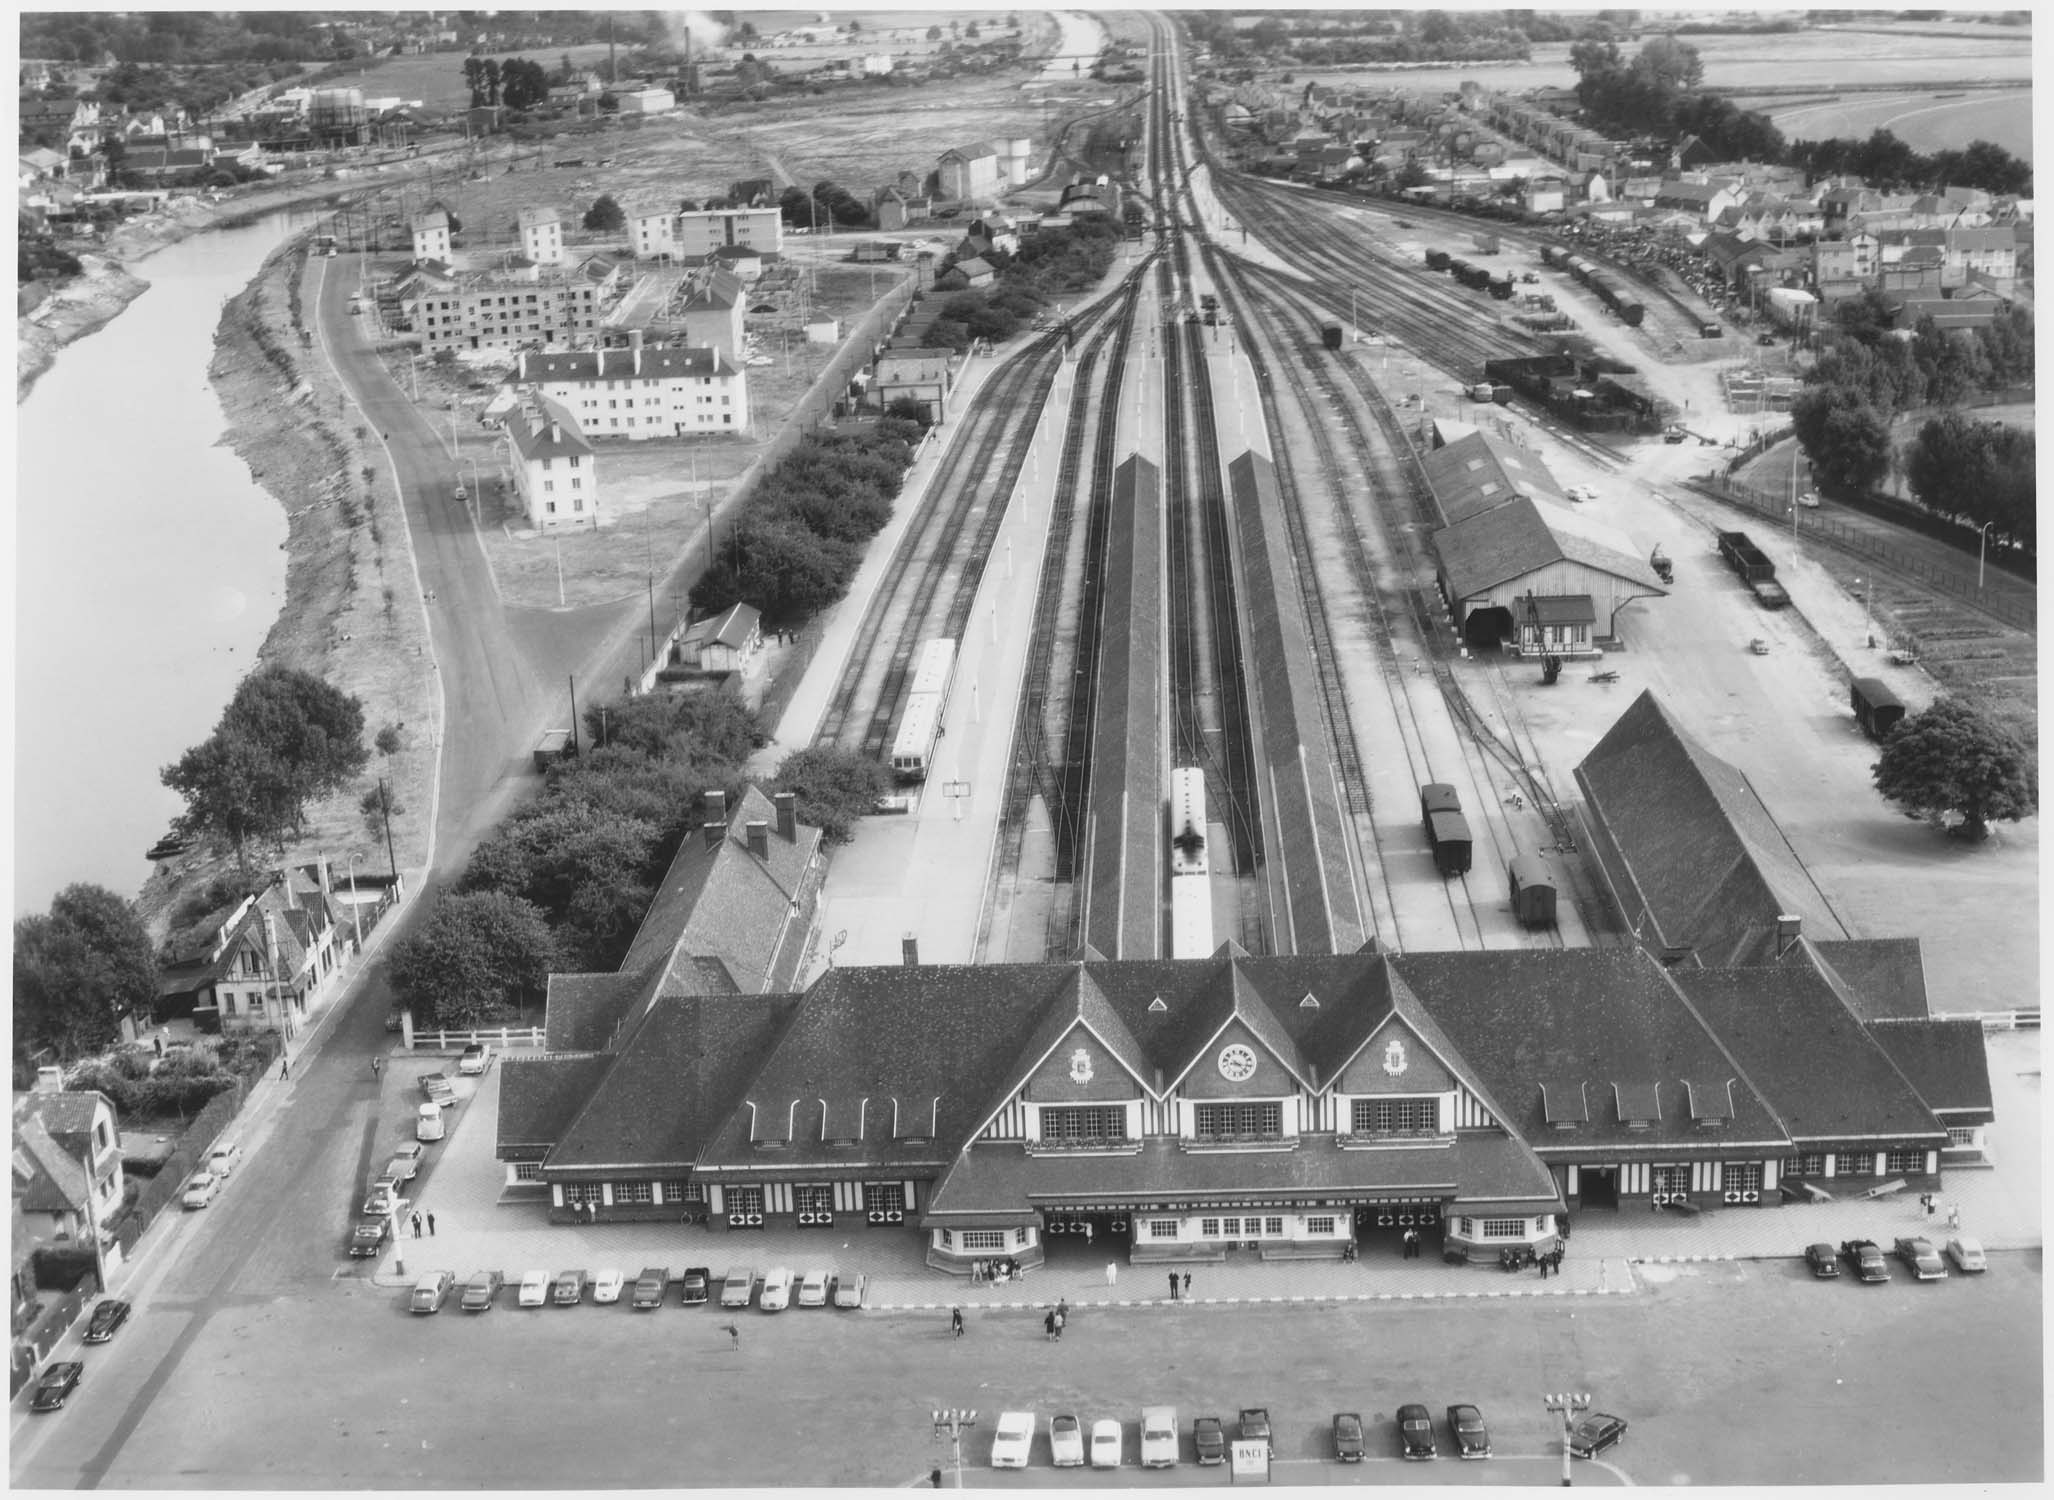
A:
[{"xmin": 14, "ymin": 884, "xmax": 156, "ymax": 1060}]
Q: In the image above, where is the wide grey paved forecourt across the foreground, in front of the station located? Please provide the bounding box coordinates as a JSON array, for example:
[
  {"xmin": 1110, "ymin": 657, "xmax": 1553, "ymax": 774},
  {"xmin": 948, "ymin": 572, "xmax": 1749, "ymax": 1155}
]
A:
[{"xmin": 14, "ymin": 1249, "xmax": 2044, "ymax": 1490}]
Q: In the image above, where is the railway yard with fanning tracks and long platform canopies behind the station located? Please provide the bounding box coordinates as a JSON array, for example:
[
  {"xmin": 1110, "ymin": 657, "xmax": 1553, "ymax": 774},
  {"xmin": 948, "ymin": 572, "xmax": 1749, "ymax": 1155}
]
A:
[{"xmin": 778, "ymin": 14, "xmax": 2031, "ymax": 994}]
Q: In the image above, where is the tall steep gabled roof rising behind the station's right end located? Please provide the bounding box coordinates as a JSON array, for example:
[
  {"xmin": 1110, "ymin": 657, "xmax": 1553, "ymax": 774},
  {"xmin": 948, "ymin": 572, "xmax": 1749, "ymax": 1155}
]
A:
[{"xmin": 1575, "ymin": 692, "xmax": 1847, "ymax": 966}]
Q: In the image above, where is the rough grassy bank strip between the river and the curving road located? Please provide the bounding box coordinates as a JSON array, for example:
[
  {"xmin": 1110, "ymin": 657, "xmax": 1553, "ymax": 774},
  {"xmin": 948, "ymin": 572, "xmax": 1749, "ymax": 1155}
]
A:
[{"xmin": 138, "ymin": 236, "xmax": 442, "ymax": 921}]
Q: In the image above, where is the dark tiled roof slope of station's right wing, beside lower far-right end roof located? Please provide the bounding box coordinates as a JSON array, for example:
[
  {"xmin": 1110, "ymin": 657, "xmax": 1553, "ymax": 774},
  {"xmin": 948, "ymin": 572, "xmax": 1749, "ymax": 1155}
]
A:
[{"xmin": 1676, "ymin": 966, "xmax": 1939, "ymax": 1142}]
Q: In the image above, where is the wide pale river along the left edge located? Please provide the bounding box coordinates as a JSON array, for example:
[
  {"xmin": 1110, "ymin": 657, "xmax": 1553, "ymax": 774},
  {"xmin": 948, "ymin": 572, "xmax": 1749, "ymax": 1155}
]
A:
[{"xmin": 14, "ymin": 214, "xmax": 304, "ymax": 914}]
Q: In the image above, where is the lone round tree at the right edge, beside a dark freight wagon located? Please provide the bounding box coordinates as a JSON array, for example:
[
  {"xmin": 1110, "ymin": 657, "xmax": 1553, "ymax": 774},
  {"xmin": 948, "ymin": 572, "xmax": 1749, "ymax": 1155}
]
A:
[{"xmin": 1875, "ymin": 699, "xmax": 2040, "ymax": 840}]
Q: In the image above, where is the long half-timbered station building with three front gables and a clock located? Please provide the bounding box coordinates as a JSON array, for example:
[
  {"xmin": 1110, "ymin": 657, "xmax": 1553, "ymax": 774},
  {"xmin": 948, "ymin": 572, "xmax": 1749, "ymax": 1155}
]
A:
[{"xmin": 499, "ymin": 945, "xmax": 1974, "ymax": 1272}]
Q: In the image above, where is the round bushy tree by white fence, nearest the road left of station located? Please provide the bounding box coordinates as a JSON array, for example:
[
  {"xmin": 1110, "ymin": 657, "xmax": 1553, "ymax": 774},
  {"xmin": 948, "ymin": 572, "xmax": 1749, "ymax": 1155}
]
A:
[{"xmin": 388, "ymin": 890, "xmax": 559, "ymax": 1027}]
